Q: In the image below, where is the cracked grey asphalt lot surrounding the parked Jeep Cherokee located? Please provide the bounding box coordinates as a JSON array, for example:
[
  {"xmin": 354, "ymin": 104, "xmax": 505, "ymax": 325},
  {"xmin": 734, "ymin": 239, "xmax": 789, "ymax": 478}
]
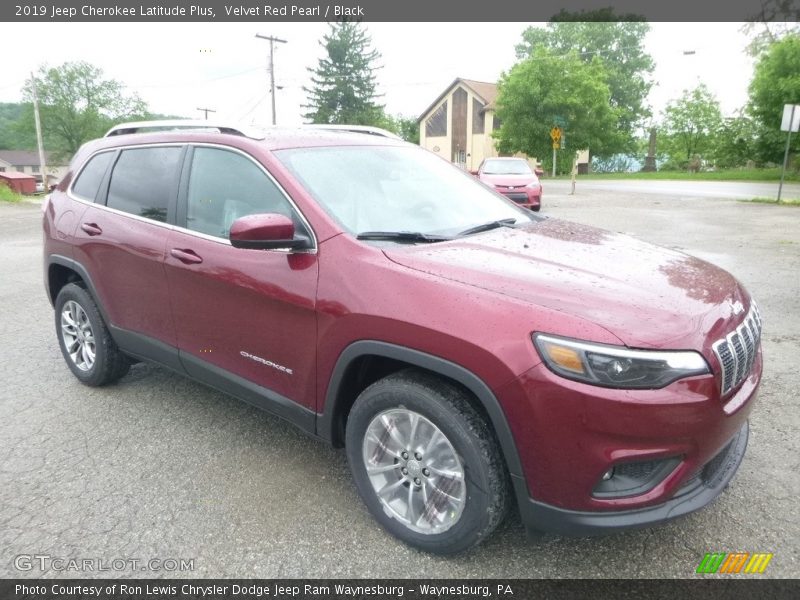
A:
[{"xmin": 0, "ymin": 186, "xmax": 800, "ymax": 578}]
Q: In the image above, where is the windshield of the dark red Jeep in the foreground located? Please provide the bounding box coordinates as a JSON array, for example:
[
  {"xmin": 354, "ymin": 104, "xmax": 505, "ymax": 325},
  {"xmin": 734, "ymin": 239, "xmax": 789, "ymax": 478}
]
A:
[{"xmin": 275, "ymin": 146, "xmax": 534, "ymax": 241}]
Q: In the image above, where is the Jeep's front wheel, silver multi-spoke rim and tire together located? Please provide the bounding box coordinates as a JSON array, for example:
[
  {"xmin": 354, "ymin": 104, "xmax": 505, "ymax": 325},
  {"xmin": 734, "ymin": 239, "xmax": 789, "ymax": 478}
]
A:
[{"xmin": 346, "ymin": 370, "xmax": 509, "ymax": 554}]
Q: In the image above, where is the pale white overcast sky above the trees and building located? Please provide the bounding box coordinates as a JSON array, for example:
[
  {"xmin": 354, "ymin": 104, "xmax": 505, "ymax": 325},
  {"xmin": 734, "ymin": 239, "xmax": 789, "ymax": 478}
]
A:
[{"xmin": 0, "ymin": 22, "xmax": 753, "ymax": 125}]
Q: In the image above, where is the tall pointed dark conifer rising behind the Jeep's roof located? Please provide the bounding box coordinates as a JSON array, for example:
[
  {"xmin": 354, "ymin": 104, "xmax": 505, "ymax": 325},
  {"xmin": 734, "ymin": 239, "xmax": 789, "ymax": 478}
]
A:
[{"xmin": 303, "ymin": 21, "xmax": 387, "ymax": 127}]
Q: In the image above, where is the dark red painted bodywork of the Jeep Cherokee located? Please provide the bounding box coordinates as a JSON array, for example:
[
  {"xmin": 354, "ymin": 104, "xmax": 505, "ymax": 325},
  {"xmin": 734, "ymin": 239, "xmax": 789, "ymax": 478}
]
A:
[{"xmin": 44, "ymin": 132, "xmax": 762, "ymax": 528}]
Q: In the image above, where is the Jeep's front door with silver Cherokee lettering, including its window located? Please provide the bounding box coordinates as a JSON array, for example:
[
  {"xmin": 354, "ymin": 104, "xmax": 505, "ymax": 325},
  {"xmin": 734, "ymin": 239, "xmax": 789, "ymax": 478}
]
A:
[{"xmin": 165, "ymin": 146, "xmax": 318, "ymax": 416}]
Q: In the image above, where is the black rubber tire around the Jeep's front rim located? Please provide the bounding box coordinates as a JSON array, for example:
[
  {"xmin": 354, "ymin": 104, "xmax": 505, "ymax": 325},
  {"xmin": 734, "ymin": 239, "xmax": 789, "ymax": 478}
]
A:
[{"xmin": 346, "ymin": 369, "xmax": 511, "ymax": 554}]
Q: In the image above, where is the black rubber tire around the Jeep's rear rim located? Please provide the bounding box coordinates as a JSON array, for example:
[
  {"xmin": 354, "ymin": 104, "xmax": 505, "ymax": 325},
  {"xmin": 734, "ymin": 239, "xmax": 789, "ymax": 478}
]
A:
[{"xmin": 55, "ymin": 283, "xmax": 131, "ymax": 387}]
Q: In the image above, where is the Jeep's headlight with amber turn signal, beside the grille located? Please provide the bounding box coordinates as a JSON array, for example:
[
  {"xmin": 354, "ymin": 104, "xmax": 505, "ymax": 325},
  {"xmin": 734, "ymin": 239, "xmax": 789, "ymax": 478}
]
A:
[{"xmin": 533, "ymin": 333, "xmax": 711, "ymax": 389}]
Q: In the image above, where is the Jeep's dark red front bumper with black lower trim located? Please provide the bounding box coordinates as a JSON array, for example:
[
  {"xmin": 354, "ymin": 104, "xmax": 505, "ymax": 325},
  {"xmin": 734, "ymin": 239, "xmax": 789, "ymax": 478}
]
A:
[{"xmin": 497, "ymin": 351, "xmax": 762, "ymax": 535}]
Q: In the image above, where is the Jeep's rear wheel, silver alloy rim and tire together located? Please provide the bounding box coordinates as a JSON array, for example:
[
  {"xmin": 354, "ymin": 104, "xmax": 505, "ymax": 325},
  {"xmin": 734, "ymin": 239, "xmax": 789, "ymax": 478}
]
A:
[{"xmin": 55, "ymin": 283, "xmax": 130, "ymax": 386}]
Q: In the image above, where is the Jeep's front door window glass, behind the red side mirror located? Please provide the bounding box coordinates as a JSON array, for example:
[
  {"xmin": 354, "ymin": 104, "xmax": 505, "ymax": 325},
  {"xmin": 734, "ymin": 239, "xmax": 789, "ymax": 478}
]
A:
[{"xmin": 186, "ymin": 147, "xmax": 299, "ymax": 238}]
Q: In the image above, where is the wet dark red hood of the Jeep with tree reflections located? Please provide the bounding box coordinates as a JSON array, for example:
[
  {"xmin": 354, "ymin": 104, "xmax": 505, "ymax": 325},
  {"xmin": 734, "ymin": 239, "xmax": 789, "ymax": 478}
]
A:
[{"xmin": 384, "ymin": 219, "xmax": 749, "ymax": 353}]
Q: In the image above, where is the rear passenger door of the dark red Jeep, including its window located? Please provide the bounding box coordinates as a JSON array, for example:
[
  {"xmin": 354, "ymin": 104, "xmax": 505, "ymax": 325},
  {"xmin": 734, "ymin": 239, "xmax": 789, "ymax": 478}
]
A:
[{"xmin": 73, "ymin": 145, "xmax": 185, "ymax": 358}]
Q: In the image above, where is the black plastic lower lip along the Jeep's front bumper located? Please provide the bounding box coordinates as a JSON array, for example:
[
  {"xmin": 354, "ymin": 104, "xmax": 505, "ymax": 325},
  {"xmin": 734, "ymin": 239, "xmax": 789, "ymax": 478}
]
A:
[{"xmin": 519, "ymin": 423, "xmax": 749, "ymax": 536}]
